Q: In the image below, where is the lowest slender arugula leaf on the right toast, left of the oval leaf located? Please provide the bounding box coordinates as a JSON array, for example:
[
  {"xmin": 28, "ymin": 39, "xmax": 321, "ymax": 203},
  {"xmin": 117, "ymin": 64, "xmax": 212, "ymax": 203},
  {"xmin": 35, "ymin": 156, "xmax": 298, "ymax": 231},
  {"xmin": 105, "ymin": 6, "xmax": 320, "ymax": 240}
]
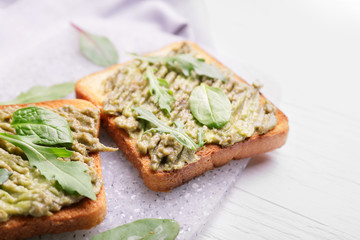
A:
[{"xmin": 134, "ymin": 107, "xmax": 199, "ymax": 150}]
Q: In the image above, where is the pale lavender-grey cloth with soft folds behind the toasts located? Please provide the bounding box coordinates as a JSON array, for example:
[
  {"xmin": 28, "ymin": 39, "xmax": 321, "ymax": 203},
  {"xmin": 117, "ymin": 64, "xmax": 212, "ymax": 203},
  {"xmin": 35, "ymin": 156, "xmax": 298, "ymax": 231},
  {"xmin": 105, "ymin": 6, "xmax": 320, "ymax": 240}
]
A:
[{"xmin": 0, "ymin": 0, "xmax": 211, "ymax": 97}]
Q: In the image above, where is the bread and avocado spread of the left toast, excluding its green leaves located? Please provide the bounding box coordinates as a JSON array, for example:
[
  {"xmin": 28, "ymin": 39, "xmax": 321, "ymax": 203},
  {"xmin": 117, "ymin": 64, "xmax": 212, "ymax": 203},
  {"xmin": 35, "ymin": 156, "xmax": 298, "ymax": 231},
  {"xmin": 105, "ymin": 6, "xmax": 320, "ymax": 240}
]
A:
[{"xmin": 0, "ymin": 100, "xmax": 110, "ymax": 239}]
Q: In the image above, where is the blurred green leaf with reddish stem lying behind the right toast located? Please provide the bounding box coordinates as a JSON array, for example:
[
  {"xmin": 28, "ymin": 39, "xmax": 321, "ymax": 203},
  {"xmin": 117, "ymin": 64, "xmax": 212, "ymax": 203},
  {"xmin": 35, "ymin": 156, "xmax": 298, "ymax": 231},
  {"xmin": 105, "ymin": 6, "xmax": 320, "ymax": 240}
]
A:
[{"xmin": 71, "ymin": 23, "xmax": 119, "ymax": 67}]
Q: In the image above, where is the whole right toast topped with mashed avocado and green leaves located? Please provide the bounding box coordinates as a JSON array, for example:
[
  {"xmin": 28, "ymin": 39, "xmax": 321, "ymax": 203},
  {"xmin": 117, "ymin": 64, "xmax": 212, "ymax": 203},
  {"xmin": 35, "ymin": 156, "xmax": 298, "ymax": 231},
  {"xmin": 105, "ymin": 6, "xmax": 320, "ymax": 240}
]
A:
[{"xmin": 75, "ymin": 42, "xmax": 289, "ymax": 192}]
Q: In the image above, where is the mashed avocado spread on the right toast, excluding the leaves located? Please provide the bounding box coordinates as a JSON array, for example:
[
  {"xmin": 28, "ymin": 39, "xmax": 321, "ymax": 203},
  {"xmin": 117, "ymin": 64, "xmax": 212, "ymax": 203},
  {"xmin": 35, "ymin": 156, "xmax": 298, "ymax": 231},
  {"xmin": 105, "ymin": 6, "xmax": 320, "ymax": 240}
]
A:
[{"xmin": 103, "ymin": 44, "xmax": 277, "ymax": 171}]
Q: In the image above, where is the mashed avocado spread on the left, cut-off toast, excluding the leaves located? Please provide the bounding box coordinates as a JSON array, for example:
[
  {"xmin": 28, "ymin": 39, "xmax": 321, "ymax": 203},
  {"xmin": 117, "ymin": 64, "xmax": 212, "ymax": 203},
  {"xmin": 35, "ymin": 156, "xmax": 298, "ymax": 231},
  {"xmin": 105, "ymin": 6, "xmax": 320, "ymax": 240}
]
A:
[{"xmin": 0, "ymin": 106, "xmax": 112, "ymax": 222}]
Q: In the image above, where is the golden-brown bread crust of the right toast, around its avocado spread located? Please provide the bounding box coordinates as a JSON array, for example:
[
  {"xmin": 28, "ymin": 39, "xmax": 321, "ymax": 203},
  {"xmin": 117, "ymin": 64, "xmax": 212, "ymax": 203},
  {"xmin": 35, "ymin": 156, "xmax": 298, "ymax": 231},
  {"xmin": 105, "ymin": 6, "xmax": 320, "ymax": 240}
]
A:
[{"xmin": 75, "ymin": 42, "xmax": 289, "ymax": 192}]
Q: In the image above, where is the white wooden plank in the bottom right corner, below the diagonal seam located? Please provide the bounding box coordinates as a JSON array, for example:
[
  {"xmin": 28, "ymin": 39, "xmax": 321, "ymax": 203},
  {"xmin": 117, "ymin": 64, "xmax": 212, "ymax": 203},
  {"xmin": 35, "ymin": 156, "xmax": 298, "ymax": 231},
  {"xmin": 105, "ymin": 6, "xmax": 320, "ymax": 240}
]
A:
[{"xmin": 198, "ymin": 188, "xmax": 359, "ymax": 240}]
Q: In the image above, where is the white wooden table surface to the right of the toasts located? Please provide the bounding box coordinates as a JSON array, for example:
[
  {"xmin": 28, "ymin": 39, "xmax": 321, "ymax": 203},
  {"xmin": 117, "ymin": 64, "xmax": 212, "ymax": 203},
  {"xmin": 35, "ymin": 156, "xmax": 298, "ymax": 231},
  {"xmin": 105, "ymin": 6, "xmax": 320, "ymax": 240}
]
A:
[{"xmin": 199, "ymin": 0, "xmax": 360, "ymax": 240}]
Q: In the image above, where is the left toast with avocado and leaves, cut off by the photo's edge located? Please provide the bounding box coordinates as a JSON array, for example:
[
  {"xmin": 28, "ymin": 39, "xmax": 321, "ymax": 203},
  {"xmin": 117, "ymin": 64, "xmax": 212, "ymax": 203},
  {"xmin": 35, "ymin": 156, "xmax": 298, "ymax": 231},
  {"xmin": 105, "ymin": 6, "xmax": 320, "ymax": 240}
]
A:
[{"xmin": 0, "ymin": 99, "xmax": 113, "ymax": 240}]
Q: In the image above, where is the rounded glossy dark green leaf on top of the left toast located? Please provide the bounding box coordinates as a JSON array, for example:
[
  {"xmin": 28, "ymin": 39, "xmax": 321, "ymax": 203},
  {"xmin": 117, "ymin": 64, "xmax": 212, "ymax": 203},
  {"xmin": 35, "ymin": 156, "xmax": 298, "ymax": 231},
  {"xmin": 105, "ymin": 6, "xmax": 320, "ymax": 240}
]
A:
[{"xmin": 11, "ymin": 107, "xmax": 73, "ymax": 146}]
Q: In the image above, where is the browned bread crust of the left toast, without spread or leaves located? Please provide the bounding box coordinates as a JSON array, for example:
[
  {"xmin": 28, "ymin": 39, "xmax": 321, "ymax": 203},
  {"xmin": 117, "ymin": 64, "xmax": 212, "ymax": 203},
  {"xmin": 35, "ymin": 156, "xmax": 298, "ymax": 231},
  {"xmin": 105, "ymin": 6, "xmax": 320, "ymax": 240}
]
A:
[{"xmin": 0, "ymin": 99, "xmax": 106, "ymax": 240}]
